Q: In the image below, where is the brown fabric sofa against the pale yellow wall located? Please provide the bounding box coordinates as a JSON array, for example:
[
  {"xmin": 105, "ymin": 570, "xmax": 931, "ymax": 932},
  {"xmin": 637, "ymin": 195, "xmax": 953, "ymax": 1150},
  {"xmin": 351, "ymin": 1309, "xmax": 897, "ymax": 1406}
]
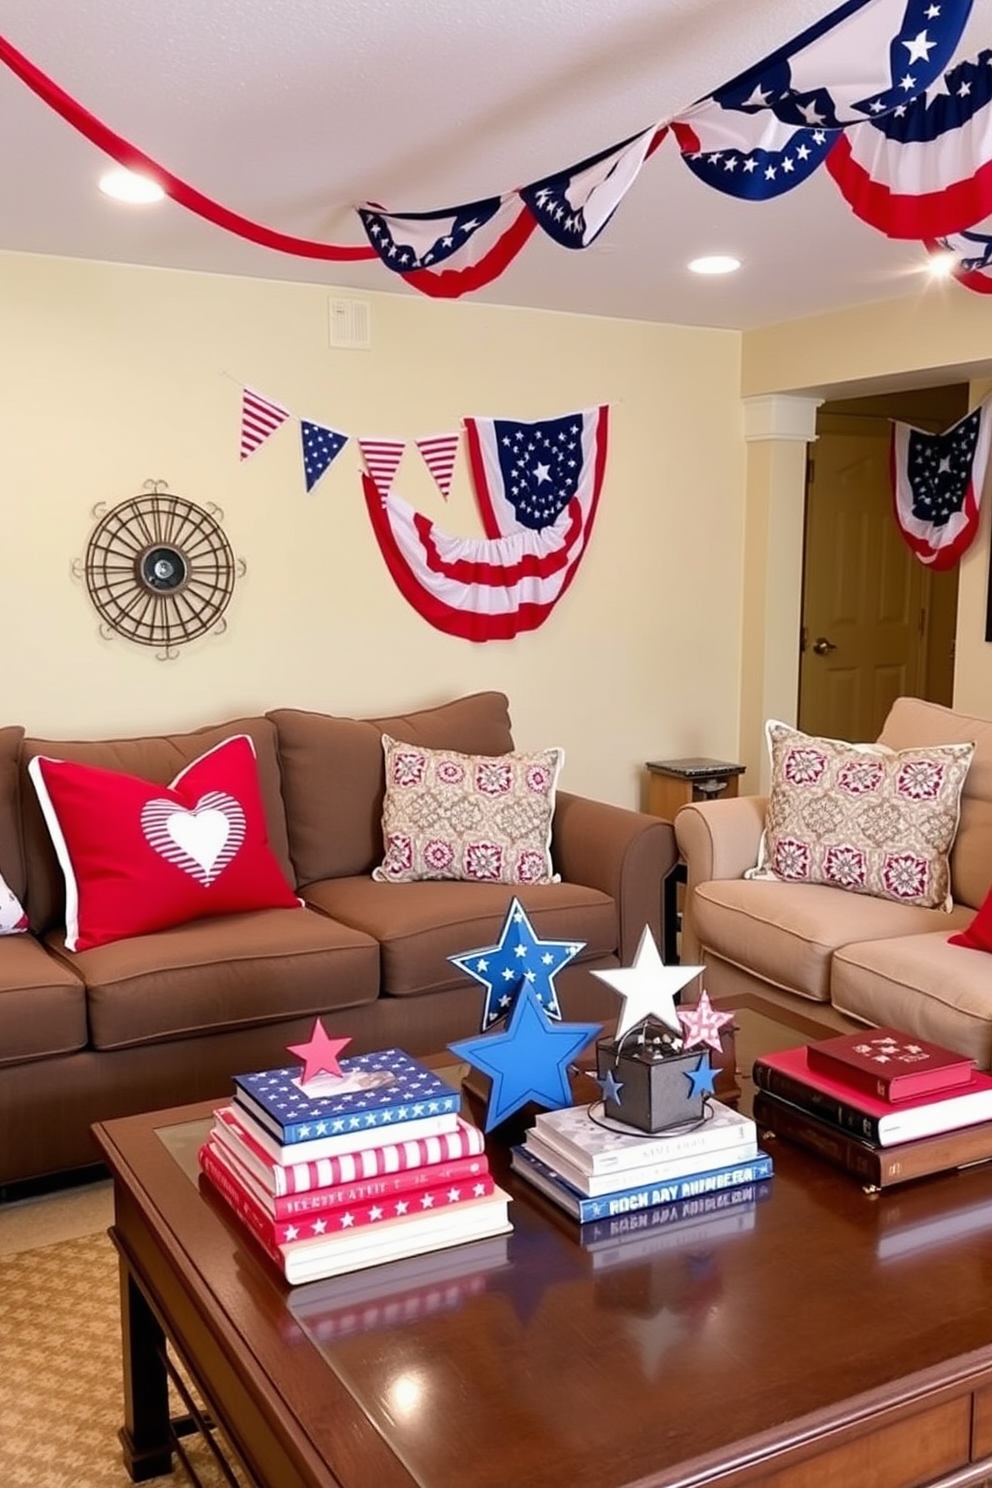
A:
[{"xmin": 0, "ymin": 692, "xmax": 675, "ymax": 1189}]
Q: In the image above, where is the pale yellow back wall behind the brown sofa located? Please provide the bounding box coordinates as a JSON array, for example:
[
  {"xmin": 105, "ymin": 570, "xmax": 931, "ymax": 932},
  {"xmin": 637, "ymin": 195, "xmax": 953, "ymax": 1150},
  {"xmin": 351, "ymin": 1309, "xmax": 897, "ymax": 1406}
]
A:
[{"xmin": 0, "ymin": 254, "xmax": 745, "ymax": 805}]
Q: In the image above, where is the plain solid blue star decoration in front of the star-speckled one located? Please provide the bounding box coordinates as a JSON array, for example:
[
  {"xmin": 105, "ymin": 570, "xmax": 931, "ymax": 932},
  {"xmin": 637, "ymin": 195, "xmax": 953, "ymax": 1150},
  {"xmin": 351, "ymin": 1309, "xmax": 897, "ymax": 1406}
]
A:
[{"xmin": 448, "ymin": 982, "xmax": 602, "ymax": 1131}]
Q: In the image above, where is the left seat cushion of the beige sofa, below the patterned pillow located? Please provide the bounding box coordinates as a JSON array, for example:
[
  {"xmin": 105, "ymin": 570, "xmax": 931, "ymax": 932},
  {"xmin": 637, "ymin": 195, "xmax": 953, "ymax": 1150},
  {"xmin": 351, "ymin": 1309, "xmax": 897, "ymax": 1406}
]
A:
[{"xmin": 693, "ymin": 878, "xmax": 970, "ymax": 1005}]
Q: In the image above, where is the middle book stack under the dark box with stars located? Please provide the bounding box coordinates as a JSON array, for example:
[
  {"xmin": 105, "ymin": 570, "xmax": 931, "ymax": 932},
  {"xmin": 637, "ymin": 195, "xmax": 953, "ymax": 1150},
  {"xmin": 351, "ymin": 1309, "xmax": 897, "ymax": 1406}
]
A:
[{"xmin": 510, "ymin": 1101, "xmax": 772, "ymax": 1225}]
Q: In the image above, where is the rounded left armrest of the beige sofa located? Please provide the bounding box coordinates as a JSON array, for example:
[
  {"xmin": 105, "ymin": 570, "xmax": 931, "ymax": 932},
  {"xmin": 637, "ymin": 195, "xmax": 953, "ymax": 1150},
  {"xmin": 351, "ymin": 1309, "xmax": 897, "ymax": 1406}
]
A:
[{"xmin": 675, "ymin": 796, "xmax": 767, "ymax": 964}]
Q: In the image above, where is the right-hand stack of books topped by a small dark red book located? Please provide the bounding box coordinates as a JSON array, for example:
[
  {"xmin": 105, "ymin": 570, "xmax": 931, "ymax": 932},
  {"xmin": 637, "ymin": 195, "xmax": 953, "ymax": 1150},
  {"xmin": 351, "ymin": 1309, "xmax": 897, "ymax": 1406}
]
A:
[{"xmin": 753, "ymin": 1028, "xmax": 992, "ymax": 1189}]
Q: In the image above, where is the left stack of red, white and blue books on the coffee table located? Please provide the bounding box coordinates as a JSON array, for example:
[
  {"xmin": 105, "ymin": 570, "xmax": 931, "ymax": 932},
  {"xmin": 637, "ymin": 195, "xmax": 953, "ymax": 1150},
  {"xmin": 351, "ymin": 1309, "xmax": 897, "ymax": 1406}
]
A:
[{"xmin": 199, "ymin": 1049, "xmax": 512, "ymax": 1286}]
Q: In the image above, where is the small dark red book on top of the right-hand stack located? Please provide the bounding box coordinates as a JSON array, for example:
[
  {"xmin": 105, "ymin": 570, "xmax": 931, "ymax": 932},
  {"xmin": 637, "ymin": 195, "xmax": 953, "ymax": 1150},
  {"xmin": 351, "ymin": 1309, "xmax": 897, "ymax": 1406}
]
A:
[{"xmin": 806, "ymin": 1028, "xmax": 974, "ymax": 1103}]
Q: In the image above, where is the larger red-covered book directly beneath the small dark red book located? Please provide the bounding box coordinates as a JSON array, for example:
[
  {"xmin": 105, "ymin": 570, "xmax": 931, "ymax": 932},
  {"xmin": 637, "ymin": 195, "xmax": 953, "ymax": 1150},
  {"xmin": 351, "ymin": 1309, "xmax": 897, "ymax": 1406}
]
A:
[{"xmin": 753, "ymin": 1045, "xmax": 992, "ymax": 1147}]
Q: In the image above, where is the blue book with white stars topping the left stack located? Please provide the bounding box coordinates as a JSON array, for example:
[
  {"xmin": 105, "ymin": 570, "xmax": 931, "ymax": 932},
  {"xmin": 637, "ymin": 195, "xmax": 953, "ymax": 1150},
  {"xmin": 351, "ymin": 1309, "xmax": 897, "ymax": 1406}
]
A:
[{"xmin": 235, "ymin": 1049, "xmax": 461, "ymax": 1161}]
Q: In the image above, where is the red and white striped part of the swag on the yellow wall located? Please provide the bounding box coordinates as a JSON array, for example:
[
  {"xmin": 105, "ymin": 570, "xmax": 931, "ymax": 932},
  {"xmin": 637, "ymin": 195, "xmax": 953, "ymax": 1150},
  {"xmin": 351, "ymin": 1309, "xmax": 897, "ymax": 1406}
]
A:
[{"xmin": 363, "ymin": 406, "xmax": 608, "ymax": 641}]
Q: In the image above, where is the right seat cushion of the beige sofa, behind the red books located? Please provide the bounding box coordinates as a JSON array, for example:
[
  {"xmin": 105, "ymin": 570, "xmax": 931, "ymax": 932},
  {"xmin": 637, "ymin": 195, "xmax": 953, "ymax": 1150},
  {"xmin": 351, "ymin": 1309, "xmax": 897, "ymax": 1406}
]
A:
[{"xmin": 830, "ymin": 912, "xmax": 992, "ymax": 1070}]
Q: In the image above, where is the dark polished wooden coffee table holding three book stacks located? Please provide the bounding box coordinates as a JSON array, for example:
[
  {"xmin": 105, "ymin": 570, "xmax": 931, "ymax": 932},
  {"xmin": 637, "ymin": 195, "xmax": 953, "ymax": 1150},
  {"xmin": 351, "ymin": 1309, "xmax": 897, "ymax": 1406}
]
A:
[{"xmin": 95, "ymin": 998, "xmax": 992, "ymax": 1488}]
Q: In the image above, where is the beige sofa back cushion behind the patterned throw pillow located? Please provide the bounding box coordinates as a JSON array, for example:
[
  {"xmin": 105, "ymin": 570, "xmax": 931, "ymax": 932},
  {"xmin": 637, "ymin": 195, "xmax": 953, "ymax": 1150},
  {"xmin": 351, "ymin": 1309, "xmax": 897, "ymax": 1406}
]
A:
[{"xmin": 879, "ymin": 698, "xmax": 992, "ymax": 909}]
